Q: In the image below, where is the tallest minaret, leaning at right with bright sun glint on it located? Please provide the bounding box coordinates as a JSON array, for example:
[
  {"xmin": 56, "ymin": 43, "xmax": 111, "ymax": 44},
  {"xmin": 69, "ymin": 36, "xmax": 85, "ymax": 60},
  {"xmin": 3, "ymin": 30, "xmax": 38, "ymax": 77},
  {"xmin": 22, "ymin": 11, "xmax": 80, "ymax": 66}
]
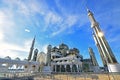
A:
[{"xmin": 87, "ymin": 9, "xmax": 117, "ymax": 66}]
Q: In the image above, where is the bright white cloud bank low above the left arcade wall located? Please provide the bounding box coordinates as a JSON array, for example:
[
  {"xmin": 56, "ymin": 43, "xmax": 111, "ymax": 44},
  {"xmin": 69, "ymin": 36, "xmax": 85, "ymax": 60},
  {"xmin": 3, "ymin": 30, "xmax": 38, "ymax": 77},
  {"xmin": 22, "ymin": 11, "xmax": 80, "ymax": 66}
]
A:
[{"xmin": 0, "ymin": 40, "xmax": 32, "ymax": 59}]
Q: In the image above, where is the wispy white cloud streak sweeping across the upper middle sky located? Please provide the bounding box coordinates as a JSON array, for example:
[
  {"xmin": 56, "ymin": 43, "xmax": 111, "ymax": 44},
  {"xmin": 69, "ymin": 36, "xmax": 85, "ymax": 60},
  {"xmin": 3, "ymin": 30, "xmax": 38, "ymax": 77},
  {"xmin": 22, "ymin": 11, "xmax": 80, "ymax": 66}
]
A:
[{"xmin": 1, "ymin": 0, "xmax": 82, "ymax": 36}]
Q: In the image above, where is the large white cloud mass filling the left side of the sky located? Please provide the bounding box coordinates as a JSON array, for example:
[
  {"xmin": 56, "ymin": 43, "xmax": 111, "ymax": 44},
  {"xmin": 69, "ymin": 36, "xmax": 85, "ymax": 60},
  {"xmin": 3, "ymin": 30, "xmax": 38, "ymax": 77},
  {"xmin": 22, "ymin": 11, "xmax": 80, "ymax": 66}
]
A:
[{"xmin": 0, "ymin": 0, "xmax": 44, "ymax": 59}]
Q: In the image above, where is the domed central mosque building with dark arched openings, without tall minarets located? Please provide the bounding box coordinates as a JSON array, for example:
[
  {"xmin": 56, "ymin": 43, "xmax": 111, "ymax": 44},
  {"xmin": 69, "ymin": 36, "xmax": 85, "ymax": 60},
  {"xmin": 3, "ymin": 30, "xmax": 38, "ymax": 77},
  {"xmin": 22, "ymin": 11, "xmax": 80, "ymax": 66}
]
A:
[{"xmin": 37, "ymin": 43, "xmax": 99, "ymax": 72}]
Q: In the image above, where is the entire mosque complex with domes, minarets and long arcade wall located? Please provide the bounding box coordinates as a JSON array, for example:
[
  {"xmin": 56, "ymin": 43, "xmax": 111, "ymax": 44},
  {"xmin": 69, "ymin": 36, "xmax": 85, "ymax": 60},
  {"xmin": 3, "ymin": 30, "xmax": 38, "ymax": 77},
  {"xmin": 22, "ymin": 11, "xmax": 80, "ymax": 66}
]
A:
[{"xmin": 0, "ymin": 10, "xmax": 120, "ymax": 73}]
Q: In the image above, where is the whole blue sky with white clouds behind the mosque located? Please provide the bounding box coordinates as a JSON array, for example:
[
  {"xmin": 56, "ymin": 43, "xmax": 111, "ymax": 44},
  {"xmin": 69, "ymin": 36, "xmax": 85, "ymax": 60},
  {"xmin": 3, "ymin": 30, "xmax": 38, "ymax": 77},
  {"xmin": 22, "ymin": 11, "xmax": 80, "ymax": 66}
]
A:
[{"xmin": 0, "ymin": 0, "xmax": 120, "ymax": 66}]
